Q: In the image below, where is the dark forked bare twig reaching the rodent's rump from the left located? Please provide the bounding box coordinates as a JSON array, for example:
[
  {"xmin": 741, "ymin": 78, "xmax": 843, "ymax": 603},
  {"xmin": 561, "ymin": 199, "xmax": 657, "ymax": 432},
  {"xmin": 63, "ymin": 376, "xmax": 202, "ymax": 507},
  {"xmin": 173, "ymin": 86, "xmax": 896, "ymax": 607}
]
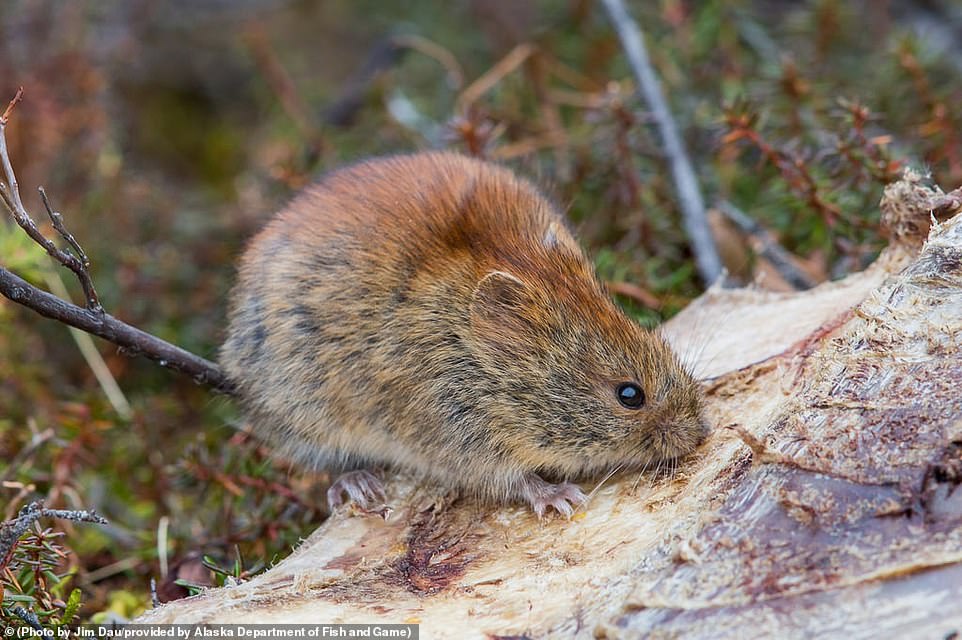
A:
[{"xmin": 0, "ymin": 88, "xmax": 232, "ymax": 393}]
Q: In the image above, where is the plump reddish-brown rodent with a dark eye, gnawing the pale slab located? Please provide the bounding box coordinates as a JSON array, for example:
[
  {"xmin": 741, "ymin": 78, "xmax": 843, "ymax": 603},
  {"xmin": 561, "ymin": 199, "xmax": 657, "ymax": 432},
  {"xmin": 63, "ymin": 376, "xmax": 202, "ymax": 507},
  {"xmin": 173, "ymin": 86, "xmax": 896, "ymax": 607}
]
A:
[{"xmin": 221, "ymin": 152, "xmax": 706, "ymax": 516}]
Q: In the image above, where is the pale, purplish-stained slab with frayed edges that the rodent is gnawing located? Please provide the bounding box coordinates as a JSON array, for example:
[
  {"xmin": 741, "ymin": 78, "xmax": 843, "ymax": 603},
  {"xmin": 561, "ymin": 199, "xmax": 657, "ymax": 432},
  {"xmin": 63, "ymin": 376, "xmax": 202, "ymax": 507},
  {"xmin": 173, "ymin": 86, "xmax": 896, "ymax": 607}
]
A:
[{"xmin": 140, "ymin": 176, "xmax": 962, "ymax": 638}]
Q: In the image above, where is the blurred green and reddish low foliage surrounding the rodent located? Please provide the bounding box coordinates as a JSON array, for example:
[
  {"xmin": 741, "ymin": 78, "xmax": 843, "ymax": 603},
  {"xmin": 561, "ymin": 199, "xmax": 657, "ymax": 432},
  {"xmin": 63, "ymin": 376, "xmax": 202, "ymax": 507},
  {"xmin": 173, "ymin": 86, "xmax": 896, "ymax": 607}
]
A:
[{"xmin": 0, "ymin": 0, "xmax": 962, "ymax": 623}]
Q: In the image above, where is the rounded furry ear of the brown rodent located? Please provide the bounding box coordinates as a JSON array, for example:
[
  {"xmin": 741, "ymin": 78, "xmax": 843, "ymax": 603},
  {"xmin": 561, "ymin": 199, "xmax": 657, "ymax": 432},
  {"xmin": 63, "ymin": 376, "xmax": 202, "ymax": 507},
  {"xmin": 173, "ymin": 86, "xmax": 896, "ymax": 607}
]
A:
[{"xmin": 471, "ymin": 271, "xmax": 536, "ymax": 353}]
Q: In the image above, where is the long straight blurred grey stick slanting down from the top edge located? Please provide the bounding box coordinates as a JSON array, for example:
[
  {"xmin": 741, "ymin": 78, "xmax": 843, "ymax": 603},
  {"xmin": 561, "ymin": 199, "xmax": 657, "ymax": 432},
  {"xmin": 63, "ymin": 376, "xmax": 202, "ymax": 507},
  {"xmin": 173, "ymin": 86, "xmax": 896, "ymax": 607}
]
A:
[{"xmin": 602, "ymin": 0, "xmax": 722, "ymax": 284}]
